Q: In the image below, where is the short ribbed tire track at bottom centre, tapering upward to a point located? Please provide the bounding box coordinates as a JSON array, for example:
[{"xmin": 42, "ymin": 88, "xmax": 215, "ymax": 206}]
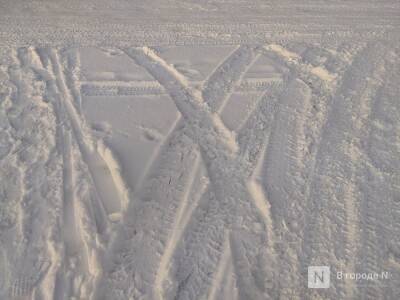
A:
[{"xmin": 171, "ymin": 188, "xmax": 226, "ymax": 300}]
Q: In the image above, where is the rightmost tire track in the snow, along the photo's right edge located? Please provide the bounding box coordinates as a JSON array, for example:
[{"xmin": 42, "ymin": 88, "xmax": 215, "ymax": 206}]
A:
[{"xmin": 358, "ymin": 49, "xmax": 400, "ymax": 299}]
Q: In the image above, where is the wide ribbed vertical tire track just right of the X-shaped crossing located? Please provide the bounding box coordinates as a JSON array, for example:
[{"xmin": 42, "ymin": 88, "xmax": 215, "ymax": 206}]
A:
[{"xmin": 262, "ymin": 79, "xmax": 312, "ymax": 298}]
